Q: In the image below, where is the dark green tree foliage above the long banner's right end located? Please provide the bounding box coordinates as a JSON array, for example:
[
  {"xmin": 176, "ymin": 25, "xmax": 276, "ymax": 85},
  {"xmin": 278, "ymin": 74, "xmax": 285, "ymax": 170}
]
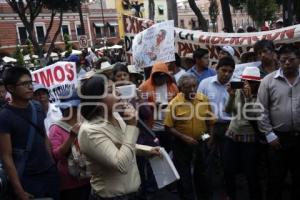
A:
[{"xmin": 246, "ymin": 0, "xmax": 279, "ymax": 27}]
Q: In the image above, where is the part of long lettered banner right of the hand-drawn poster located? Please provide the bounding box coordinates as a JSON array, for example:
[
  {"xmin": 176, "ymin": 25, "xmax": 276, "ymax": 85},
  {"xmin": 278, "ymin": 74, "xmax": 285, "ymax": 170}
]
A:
[{"xmin": 175, "ymin": 25, "xmax": 300, "ymax": 59}]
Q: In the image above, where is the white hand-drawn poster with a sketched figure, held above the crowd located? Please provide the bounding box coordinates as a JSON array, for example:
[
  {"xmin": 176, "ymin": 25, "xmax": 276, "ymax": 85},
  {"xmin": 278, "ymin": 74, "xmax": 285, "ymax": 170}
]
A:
[{"xmin": 132, "ymin": 20, "xmax": 175, "ymax": 68}]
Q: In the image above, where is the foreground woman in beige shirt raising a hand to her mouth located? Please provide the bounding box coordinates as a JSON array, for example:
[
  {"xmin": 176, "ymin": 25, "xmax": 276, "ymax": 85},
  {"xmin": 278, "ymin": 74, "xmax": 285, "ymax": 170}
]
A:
[{"xmin": 78, "ymin": 75, "xmax": 159, "ymax": 200}]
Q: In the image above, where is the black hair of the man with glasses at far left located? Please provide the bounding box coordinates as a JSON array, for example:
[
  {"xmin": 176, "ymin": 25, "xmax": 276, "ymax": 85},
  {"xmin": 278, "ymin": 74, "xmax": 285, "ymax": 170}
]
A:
[{"xmin": 2, "ymin": 67, "xmax": 31, "ymax": 90}]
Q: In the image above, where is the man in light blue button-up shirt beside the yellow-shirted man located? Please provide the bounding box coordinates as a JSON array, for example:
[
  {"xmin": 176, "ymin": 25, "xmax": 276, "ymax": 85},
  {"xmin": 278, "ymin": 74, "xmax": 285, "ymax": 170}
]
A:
[{"xmin": 198, "ymin": 57, "xmax": 235, "ymax": 137}]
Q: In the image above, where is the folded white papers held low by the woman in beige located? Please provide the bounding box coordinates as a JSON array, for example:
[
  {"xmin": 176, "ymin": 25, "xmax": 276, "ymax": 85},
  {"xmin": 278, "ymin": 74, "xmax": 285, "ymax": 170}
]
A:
[{"xmin": 149, "ymin": 148, "xmax": 180, "ymax": 189}]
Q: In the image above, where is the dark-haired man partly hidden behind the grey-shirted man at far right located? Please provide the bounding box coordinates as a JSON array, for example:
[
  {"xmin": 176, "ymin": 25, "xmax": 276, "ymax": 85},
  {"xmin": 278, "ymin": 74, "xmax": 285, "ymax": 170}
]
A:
[{"xmin": 254, "ymin": 40, "xmax": 278, "ymax": 78}]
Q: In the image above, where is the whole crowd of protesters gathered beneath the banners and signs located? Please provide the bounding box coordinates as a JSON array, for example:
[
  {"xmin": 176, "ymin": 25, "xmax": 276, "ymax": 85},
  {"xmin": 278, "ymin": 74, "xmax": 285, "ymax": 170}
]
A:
[{"xmin": 0, "ymin": 36, "xmax": 300, "ymax": 200}]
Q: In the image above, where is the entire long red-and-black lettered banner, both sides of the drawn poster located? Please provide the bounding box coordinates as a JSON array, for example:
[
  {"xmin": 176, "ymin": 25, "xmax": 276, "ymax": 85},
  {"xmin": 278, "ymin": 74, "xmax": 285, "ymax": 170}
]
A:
[{"xmin": 123, "ymin": 15, "xmax": 300, "ymax": 62}]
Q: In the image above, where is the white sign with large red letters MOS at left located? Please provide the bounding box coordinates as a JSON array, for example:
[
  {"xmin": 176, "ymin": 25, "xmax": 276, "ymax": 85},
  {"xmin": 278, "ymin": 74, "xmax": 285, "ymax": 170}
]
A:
[{"xmin": 31, "ymin": 62, "xmax": 77, "ymax": 102}]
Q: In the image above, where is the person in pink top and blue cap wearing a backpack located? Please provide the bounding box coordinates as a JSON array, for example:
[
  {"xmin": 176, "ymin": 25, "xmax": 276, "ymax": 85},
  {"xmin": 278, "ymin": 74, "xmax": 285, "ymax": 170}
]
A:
[{"xmin": 49, "ymin": 91, "xmax": 91, "ymax": 200}]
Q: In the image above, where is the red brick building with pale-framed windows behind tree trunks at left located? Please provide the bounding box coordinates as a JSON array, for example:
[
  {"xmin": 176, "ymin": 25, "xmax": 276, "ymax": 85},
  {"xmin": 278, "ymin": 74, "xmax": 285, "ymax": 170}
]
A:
[{"xmin": 0, "ymin": 1, "xmax": 120, "ymax": 54}]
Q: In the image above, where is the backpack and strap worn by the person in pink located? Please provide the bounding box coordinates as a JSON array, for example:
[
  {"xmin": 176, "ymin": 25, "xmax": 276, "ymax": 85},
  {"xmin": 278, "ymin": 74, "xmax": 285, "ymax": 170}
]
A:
[{"xmin": 53, "ymin": 121, "xmax": 91, "ymax": 179}]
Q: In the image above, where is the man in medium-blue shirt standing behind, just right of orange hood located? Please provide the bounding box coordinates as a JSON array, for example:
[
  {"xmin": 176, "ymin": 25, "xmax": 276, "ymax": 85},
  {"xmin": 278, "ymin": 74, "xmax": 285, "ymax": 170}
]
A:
[{"xmin": 187, "ymin": 48, "xmax": 216, "ymax": 85}]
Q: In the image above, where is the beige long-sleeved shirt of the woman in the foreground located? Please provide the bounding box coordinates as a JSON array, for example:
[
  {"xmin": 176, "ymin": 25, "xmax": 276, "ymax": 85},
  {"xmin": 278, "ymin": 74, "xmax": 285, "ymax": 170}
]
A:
[{"xmin": 78, "ymin": 118, "xmax": 140, "ymax": 198}]
